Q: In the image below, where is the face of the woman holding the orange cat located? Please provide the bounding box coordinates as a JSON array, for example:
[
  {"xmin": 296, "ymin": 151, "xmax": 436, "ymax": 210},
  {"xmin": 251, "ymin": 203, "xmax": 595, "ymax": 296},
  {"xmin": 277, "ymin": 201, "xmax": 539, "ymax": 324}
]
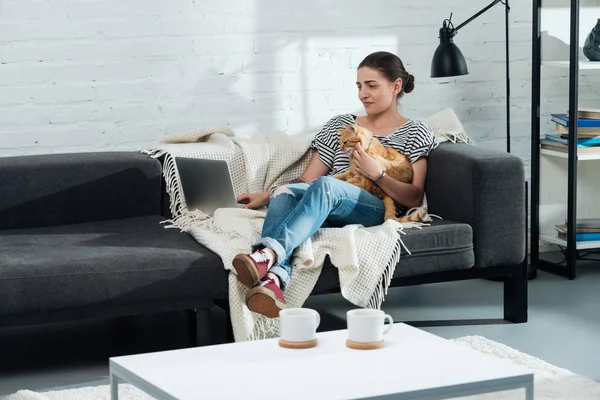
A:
[{"xmin": 356, "ymin": 67, "xmax": 402, "ymax": 114}]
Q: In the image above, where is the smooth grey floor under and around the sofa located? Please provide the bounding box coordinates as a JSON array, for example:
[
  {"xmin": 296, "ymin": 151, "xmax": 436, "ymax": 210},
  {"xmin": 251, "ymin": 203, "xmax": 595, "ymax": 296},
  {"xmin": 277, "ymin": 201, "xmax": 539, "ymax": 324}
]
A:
[{"xmin": 0, "ymin": 261, "xmax": 600, "ymax": 399}]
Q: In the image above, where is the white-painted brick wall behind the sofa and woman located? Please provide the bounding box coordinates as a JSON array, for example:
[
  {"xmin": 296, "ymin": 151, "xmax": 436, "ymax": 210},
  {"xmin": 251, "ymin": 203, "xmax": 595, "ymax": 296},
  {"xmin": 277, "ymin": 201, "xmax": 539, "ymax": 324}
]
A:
[{"xmin": 0, "ymin": 0, "xmax": 600, "ymax": 171}]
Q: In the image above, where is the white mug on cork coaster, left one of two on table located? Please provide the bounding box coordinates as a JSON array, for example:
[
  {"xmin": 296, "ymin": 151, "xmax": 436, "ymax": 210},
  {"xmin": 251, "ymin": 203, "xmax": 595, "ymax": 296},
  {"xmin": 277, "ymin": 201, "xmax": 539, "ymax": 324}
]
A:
[{"xmin": 279, "ymin": 308, "xmax": 321, "ymax": 342}]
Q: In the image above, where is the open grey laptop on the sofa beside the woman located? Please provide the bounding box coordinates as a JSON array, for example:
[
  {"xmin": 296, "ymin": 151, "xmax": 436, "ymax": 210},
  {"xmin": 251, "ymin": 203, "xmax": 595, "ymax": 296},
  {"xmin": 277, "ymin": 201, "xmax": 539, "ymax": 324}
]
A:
[{"xmin": 175, "ymin": 157, "xmax": 244, "ymax": 216}]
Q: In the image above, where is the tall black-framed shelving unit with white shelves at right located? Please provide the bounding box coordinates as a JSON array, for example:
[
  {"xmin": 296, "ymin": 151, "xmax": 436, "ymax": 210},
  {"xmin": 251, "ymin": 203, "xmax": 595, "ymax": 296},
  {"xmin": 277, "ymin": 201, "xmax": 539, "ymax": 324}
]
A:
[{"xmin": 530, "ymin": 0, "xmax": 600, "ymax": 279}]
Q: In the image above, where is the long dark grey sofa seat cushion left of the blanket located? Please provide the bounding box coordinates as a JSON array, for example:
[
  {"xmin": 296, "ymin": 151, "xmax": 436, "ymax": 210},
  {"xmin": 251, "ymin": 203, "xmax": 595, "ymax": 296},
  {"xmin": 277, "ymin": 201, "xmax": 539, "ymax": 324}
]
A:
[{"xmin": 0, "ymin": 215, "xmax": 228, "ymax": 315}]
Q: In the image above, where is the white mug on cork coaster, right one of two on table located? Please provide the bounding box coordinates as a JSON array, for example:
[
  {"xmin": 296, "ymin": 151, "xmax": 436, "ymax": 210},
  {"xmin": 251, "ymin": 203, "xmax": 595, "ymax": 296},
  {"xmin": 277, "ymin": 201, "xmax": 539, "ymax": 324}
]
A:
[{"xmin": 346, "ymin": 308, "xmax": 394, "ymax": 343}]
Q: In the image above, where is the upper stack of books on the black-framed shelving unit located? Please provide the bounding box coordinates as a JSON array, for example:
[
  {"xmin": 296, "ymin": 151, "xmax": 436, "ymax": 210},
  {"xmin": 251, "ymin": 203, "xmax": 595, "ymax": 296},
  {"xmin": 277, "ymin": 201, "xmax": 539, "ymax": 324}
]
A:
[{"xmin": 541, "ymin": 109, "xmax": 600, "ymax": 154}]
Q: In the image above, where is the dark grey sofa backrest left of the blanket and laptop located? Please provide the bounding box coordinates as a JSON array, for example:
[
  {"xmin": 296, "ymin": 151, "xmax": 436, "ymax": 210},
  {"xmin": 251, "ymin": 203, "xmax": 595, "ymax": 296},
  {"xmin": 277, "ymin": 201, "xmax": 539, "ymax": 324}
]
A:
[{"xmin": 0, "ymin": 151, "xmax": 162, "ymax": 229}]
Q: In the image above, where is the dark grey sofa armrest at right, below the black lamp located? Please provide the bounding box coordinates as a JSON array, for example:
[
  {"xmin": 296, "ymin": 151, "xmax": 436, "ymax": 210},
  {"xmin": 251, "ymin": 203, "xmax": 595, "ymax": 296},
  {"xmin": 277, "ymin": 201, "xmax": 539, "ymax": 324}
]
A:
[{"xmin": 426, "ymin": 142, "xmax": 526, "ymax": 267}]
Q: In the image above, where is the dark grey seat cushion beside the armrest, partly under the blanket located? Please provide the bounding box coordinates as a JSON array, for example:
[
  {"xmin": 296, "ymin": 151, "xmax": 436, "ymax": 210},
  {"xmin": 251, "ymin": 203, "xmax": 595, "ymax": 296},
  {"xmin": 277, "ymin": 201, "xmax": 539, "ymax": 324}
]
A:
[{"xmin": 313, "ymin": 219, "xmax": 475, "ymax": 293}]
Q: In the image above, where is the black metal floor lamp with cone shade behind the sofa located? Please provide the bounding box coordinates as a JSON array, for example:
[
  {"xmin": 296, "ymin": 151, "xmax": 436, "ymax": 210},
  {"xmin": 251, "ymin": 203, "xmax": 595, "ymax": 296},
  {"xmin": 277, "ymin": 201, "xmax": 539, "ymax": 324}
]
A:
[{"xmin": 431, "ymin": 0, "xmax": 510, "ymax": 153}]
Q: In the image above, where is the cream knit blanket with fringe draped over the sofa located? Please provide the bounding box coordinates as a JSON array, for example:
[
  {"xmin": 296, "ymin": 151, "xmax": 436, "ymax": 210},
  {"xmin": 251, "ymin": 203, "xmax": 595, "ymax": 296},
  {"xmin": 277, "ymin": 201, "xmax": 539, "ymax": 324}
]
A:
[{"xmin": 144, "ymin": 110, "xmax": 469, "ymax": 341}]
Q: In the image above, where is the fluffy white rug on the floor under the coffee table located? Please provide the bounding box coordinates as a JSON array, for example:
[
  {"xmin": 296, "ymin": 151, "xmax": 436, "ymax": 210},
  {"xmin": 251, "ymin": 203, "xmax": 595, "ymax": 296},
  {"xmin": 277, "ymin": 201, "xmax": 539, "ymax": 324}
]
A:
[{"xmin": 5, "ymin": 336, "xmax": 600, "ymax": 400}]
